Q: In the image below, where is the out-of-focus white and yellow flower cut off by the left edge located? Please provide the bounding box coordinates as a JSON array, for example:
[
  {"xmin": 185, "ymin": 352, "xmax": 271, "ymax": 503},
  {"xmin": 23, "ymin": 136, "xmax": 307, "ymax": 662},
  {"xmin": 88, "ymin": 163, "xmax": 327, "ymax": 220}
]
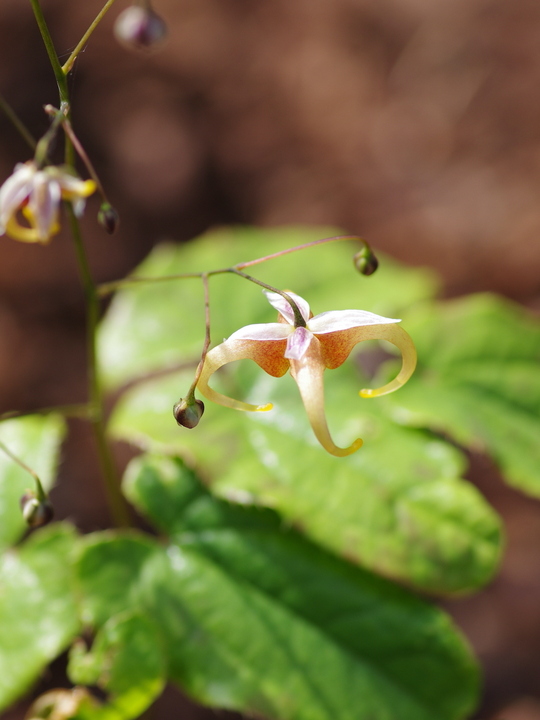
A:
[{"xmin": 0, "ymin": 160, "xmax": 96, "ymax": 244}]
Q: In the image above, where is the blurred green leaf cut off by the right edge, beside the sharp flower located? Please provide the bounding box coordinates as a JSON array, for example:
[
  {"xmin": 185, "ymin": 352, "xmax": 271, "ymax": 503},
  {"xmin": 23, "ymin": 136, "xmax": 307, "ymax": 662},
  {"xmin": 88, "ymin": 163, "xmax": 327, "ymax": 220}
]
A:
[{"xmin": 388, "ymin": 295, "xmax": 540, "ymax": 497}]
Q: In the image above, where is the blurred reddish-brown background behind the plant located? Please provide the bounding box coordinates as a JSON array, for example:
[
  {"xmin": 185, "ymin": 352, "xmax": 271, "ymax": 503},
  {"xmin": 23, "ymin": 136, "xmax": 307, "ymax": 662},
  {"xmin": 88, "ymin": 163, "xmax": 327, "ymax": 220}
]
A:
[{"xmin": 0, "ymin": 0, "xmax": 540, "ymax": 720}]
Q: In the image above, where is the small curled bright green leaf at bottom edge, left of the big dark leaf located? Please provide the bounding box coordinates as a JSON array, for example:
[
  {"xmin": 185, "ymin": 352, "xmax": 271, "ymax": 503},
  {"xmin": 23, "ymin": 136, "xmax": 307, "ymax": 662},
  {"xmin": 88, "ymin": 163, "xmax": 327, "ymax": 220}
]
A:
[{"xmin": 68, "ymin": 613, "xmax": 166, "ymax": 720}]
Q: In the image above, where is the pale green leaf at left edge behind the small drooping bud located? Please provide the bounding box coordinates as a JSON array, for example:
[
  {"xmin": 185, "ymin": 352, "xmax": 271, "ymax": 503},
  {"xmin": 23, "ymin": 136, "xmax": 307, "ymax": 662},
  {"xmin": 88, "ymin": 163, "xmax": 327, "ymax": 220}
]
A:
[{"xmin": 0, "ymin": 415, "xmax": 65, "ymax": 551}]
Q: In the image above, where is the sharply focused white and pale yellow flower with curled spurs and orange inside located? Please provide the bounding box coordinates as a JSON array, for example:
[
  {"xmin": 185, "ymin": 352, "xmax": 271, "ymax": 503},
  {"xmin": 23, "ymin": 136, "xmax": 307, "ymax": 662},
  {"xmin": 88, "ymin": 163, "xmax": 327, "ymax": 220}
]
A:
[{"xmin": 197, "ymin": 292, "xmax": 416, "ymax": 457}]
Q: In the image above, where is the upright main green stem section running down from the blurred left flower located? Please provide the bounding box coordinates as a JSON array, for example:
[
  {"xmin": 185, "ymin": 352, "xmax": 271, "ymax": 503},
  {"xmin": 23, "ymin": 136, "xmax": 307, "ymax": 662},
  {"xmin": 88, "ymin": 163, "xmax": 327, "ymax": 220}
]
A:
[{"xmin": 66, "ymin": 203, "xmax": 130, "ymax": 527}]
